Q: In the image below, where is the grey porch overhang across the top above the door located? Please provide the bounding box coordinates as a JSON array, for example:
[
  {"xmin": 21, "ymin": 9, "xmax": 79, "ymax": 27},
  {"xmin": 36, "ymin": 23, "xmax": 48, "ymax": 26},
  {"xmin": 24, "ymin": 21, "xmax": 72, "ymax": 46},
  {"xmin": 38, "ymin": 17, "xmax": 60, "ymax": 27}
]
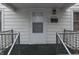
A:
[{"xmin": 2, "ymin": 3, "xmax": 75, "ymax": 10}]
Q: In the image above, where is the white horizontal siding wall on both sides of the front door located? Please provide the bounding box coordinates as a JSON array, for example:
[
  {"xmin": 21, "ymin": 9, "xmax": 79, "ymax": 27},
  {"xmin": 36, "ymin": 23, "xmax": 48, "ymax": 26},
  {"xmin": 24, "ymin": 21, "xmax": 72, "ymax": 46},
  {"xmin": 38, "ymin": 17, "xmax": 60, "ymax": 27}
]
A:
[{"xmin": 0, "ymin": 4, "xmax": 79, "ymax": 44}]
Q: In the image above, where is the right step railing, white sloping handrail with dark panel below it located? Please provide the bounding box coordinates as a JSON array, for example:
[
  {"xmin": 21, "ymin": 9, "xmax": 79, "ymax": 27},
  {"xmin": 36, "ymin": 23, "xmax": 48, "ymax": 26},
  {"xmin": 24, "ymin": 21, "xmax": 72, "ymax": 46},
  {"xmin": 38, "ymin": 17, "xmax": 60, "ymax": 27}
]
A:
[{"xmin": 56, "ymin": 33, "xmax": 71, "ymax": 55}]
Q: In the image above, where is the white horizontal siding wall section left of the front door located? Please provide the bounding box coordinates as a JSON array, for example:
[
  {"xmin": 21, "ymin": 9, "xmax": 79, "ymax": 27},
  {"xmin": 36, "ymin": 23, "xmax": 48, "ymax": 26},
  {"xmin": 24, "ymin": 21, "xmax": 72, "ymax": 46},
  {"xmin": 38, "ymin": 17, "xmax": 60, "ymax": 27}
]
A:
[{"xmin": 0, "ymin": 5, "xmax": 29, "ymax": 44}]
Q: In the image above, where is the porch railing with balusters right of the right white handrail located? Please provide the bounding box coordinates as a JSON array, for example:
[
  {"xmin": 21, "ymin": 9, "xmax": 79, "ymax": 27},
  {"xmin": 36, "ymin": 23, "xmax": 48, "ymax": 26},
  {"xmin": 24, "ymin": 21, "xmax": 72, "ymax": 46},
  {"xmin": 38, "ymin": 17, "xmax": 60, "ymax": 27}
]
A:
[{"xmin": 59, "ymin": 30, "xmax": 79, "ymax": 54}]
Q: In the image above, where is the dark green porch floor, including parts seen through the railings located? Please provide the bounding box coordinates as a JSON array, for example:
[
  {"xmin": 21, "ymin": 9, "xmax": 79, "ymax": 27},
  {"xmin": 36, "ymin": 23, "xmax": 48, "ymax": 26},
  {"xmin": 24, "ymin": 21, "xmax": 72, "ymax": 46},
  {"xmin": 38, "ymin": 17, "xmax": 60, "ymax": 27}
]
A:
[{"xmin": 11, "ymin": 44, "xmax": 71, "ymax": 55}]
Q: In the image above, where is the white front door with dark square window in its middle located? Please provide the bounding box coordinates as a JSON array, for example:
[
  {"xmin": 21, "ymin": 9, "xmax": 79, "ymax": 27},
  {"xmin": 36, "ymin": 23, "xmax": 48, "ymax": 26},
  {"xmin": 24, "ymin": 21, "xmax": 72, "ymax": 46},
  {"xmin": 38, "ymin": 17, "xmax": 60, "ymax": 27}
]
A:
[{"xmin": 31, "ymin": 12, "xmax": 46, "ymax": 44}]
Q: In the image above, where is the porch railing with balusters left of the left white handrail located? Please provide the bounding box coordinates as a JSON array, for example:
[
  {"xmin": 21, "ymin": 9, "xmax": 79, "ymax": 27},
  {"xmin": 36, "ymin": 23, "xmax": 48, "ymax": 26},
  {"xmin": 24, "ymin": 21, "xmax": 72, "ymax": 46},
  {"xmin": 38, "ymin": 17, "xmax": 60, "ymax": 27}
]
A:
[{"xmin": 0, "ymin": 30, "xmax": 20, "ymax": 55}]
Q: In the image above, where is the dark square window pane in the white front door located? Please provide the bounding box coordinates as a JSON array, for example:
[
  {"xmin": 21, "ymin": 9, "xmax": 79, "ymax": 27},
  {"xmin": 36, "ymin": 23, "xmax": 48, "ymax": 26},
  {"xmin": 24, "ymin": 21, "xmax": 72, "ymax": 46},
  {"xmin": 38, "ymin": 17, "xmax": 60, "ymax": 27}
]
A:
[{"xmin": 32, "ymin": 22, "xmax": 43, "ymax": 33}]
